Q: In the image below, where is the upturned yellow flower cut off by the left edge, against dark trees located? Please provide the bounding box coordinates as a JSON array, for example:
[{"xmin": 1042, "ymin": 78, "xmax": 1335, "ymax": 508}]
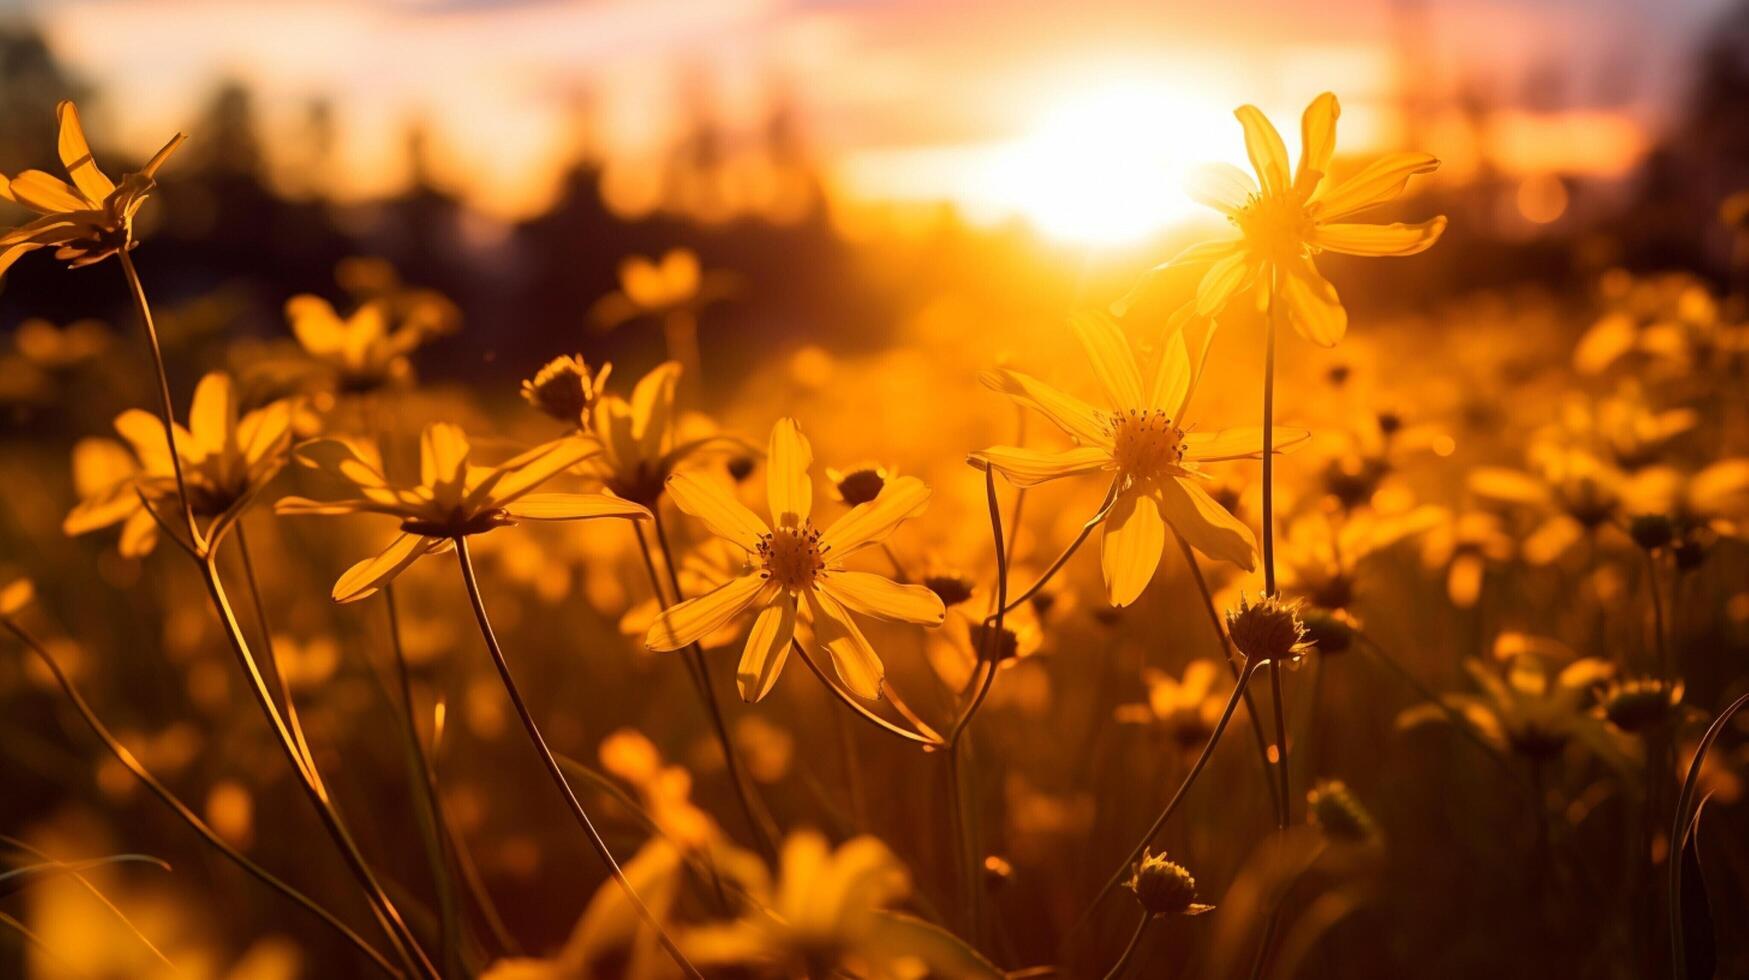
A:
[{"xmin": 0, "ymin": 102, "xmax": 184, "ymax": 275}]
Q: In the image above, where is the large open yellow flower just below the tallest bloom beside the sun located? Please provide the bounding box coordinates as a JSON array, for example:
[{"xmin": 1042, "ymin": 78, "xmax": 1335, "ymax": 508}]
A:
[{"xmin": 971, "ymin": 313, "xmax": 1308, "ymax": 606}]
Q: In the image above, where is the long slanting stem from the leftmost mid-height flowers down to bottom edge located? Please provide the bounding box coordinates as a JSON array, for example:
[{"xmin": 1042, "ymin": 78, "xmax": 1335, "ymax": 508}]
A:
[{"xmin": 201, "ymin": 541, "xmax": 439, "ymax": 977}]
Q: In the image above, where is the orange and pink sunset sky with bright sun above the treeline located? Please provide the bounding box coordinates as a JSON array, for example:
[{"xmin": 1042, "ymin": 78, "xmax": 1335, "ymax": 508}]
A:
[{"xmin": 10, "ymin": 0, "xmax": 1728, "ymax": 238}]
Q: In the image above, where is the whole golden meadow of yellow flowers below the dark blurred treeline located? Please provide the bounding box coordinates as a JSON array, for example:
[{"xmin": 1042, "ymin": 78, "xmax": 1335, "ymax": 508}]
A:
[{"xmin": 0, "ymin": 76, "xmax": 1749, "ymax": 980}]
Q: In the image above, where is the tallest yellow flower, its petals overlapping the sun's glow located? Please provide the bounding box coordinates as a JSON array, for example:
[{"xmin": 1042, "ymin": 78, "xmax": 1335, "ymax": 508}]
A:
[{"xmin": 1172, "ymin": 93, "xmax": 1445, "ymax": 347}]
